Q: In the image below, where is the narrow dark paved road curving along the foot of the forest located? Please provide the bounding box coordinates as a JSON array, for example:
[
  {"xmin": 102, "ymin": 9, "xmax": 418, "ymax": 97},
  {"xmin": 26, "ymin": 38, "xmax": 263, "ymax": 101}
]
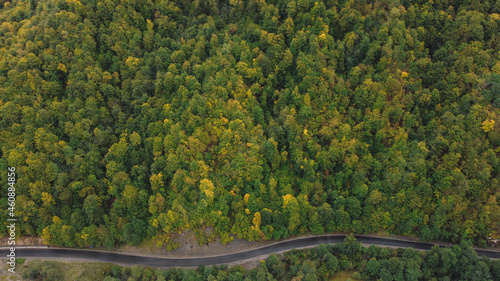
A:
[{"xmin": 0, "ymin": 235, "xmax": 500, "ymax": 267}]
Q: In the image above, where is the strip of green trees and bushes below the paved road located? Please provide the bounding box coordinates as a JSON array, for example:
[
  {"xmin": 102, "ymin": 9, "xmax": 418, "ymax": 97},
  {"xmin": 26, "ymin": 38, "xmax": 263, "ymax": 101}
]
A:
[{"xmin": 21, "ymin": 236, "xmax": 500, "ymax": 281}]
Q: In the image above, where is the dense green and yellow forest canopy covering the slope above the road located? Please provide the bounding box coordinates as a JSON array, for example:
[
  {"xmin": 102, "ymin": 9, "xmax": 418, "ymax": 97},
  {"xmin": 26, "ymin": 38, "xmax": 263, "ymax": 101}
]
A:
[{"xmin": 0, "ymin": 0, "xmax": 500, "ymax": 248}]
